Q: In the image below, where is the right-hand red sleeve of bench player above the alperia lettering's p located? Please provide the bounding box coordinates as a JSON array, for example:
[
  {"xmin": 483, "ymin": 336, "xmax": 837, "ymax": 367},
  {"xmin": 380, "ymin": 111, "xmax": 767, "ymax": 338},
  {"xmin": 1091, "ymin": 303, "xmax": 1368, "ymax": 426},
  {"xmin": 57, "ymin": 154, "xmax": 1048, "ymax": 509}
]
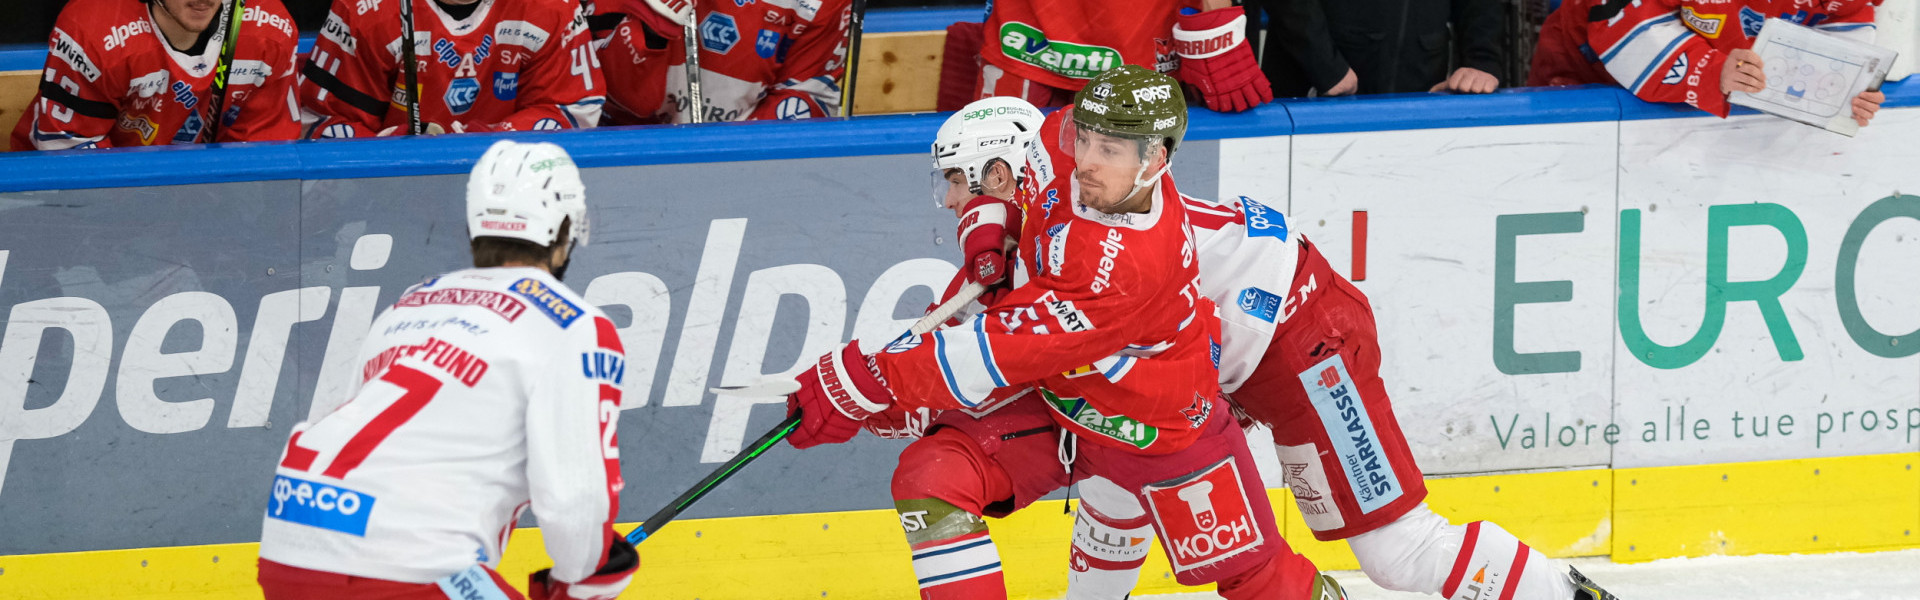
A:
[{"xmin": 749, "ymin": 0, "xmax": 852, "ymax": 119}]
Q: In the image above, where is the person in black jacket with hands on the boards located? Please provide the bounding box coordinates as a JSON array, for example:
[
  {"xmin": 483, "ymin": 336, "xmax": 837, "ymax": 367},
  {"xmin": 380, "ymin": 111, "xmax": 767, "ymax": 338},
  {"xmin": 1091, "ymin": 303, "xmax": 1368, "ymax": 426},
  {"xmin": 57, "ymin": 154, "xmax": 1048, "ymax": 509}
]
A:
[{"xmin": 1252, "ymin": 0, "xmax": 1503, "ymax": 96}]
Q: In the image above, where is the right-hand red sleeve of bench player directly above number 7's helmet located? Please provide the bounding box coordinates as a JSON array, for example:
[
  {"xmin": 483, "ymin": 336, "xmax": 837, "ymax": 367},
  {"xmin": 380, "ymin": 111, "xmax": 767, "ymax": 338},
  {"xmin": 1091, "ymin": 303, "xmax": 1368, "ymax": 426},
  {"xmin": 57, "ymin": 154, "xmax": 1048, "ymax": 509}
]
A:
[{"xmin": 488, "ymin": 0, "xmax": 607, "ymax": 131}]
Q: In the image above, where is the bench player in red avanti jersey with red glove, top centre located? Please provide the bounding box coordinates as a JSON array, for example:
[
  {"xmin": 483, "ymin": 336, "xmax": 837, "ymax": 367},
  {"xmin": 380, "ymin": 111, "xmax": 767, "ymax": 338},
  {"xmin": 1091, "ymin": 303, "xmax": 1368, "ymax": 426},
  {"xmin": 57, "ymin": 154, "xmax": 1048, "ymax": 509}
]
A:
[{"xmin": 941, "ymin": 0, "xmax": 1273, "ymax": 112}]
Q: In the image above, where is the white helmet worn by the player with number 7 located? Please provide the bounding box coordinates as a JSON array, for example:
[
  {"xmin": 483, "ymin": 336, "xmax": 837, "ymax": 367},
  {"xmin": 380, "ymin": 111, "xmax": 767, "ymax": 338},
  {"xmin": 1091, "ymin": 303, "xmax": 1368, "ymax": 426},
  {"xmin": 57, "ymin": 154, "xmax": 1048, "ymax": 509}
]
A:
[{"xmin": 467, "ymin": 140, "xmax": 588, "ymax": 246}]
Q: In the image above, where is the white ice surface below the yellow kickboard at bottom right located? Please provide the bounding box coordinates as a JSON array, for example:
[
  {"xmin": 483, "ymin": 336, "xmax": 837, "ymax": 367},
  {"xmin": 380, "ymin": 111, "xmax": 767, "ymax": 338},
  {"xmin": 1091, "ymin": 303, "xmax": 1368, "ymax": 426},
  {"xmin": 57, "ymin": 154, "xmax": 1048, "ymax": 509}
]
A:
[{"xmin": 1140, "ymin": 550, "xmax": 1920, "ymax": 600}]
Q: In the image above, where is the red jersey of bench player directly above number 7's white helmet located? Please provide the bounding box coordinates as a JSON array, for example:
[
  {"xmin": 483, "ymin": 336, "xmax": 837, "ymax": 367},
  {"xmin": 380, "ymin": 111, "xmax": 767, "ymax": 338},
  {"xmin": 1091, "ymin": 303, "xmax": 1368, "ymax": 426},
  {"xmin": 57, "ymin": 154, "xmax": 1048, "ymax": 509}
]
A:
[{"xmin": 300, "ymin": 0, "xmax": 607, "ymax": 138}]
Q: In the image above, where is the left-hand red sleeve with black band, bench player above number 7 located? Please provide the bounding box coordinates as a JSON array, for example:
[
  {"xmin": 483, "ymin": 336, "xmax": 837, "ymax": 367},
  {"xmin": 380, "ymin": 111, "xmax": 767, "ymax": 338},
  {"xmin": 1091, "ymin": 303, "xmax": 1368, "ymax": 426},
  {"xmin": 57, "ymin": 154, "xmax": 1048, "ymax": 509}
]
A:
[{"xmin": 300, "ymin": 0, "xmax": 401, "ymax": 138}]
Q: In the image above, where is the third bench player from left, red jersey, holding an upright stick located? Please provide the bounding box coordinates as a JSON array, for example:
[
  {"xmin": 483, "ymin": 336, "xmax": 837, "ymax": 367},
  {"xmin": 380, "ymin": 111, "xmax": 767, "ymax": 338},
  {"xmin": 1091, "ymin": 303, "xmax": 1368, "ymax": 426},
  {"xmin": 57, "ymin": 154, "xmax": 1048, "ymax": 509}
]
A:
[{"xmin": 593, "ymin": 0, "xmax": 852, "ymax": 125}]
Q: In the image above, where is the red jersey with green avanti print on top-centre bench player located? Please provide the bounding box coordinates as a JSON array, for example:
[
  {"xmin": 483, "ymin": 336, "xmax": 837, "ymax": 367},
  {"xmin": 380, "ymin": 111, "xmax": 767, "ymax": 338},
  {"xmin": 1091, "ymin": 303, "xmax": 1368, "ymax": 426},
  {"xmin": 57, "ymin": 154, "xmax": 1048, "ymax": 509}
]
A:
[{"xmin": 979, "ymin": 0, "xmax": 1200, "ymax": 90}]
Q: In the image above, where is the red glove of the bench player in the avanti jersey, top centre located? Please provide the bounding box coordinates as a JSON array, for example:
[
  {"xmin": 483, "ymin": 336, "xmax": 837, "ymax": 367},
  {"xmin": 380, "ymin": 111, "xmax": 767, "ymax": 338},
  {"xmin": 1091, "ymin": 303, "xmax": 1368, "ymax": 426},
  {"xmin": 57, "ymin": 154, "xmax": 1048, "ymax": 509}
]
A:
[{"xmin": 1173, "ymin": 6, "xmax": 1273, "ymax": 112}]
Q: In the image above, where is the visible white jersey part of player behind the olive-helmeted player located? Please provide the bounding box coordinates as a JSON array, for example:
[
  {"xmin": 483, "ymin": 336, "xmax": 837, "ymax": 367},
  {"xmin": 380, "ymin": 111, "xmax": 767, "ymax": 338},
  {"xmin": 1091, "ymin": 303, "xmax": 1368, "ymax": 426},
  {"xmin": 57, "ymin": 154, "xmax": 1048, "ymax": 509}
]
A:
[{"xmin": 1181, "ymin": 196, "xmax": 1300, "ymax": 394}]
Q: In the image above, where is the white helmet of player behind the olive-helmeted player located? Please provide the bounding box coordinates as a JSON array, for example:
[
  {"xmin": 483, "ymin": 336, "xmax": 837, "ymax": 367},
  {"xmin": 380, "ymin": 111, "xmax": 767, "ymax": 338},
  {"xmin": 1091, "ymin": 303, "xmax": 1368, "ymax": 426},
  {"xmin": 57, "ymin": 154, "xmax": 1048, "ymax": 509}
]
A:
[{"xmin": 933, "ymin": 98, "xmax": 1046, "ymax": 206}]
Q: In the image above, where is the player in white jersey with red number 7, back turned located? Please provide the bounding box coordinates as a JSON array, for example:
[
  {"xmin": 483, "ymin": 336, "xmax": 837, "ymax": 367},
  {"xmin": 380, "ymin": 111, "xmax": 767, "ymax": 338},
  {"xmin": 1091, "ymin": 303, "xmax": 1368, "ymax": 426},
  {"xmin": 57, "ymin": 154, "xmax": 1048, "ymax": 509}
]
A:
[{"xmin": 259, "ymin": 140, "xmax": 639, "ymax": 600}]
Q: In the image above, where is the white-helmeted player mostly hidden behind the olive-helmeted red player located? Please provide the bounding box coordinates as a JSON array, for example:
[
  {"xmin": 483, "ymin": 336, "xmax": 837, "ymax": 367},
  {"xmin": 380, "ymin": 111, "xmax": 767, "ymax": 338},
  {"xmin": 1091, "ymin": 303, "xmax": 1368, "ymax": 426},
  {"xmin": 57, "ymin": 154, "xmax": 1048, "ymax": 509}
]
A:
[{"xmin": 902, "ymin": 98, "xmax": 1613, "ymax": 600}]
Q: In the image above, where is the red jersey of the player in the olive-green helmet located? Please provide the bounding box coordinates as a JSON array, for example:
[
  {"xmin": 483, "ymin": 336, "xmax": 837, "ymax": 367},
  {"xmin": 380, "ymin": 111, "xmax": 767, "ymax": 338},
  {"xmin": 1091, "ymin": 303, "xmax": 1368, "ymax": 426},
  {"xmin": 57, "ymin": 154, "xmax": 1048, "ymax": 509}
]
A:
[{"xmin": 877, "ymin": 110, "xmax": 1219, "ymax": 454}]
